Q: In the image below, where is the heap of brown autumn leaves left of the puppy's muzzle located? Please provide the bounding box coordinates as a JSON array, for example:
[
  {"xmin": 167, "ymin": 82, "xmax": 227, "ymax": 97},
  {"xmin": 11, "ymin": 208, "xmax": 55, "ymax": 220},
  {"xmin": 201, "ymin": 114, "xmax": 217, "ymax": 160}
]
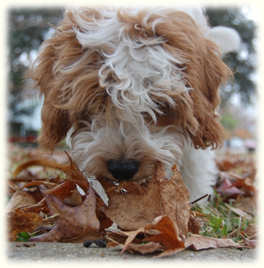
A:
[{"xmin": 8, "ymin": 152, "xmax": 100, "ymax": 241}]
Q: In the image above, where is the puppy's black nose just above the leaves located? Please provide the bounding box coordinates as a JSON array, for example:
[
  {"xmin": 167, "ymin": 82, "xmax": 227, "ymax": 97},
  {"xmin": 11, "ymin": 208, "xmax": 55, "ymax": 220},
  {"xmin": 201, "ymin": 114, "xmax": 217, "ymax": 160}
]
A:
[{"xmin": 107, "ymin": 159, "xmax": 139, "ymax": 181}]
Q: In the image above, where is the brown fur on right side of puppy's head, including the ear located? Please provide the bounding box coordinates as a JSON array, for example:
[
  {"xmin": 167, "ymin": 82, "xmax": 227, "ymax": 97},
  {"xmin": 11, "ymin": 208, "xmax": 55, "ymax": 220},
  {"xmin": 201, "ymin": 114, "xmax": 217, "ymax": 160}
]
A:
[{"xmin": 156, "ymin": 12, "xmax": 231, "ymax": 149}]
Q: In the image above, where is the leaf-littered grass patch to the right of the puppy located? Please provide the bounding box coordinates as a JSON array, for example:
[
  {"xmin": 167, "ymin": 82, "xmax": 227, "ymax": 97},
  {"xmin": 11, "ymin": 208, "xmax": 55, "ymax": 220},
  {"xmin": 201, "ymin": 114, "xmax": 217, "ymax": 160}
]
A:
[{"xmin": 192, "ymin": 153, "xmax": 257, "ymax": 247}]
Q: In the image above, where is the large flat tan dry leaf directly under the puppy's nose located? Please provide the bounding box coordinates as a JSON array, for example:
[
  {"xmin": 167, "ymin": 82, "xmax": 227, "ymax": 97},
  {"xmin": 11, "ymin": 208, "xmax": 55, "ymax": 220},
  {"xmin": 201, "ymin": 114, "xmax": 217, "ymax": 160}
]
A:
[{"xmin": 100, "ymin": 164, "xmax": 190, "ymax": 236}]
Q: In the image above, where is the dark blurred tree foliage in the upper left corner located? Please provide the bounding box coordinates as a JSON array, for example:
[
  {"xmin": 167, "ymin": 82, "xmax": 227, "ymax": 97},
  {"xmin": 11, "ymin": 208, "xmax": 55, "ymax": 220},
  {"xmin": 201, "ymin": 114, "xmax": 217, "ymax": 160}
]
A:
[{"xmin": 8, "ymin": 8, "xmax": 62, "ymax": 95}]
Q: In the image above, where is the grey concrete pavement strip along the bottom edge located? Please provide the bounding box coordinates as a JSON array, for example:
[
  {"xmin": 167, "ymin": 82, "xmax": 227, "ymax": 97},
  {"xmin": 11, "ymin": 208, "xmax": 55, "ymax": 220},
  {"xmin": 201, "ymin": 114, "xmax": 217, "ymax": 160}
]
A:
[{"xmin": 7, "ymin": 242, "xmax": 257, "ymax": 263}]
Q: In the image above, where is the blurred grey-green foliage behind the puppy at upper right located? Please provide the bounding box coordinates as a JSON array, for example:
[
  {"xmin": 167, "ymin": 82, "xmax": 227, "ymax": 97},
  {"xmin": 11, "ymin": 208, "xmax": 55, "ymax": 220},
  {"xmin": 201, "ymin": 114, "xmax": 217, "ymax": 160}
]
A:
[{"xmin": 206, "ymin": 8, "xmax": 256, "ymax": 105}]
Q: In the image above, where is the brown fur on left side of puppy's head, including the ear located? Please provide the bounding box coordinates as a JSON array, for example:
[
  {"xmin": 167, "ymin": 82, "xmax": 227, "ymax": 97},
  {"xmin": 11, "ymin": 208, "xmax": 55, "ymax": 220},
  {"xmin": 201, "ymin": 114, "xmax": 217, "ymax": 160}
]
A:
[{"xmin": 29, "ymin": 9, "xmax": 101, "ymax": 149}]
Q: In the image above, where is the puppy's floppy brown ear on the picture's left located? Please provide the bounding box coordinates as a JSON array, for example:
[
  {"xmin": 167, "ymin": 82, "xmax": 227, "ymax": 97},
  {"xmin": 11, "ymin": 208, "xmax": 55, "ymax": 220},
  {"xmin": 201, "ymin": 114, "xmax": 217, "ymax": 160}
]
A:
[{"xmin": 29, "ymin": 15, "xmax": 75, "ymax": 149}]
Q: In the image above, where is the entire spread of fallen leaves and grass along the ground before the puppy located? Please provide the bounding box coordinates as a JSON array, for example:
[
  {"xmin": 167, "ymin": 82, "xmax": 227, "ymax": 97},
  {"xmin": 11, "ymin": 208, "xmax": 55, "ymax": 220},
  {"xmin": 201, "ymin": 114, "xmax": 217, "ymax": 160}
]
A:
[{"xmin": 7, "ymin": 147, "xmax": 256, "ymax": 257}]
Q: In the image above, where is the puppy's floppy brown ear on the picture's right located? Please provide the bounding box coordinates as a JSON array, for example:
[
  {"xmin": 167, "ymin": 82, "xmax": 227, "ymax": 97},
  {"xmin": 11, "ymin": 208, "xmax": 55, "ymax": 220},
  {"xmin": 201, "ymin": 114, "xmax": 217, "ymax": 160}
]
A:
[{"xmin": 188, "ymin": 39, "xmax": 232, "ymax": 149}]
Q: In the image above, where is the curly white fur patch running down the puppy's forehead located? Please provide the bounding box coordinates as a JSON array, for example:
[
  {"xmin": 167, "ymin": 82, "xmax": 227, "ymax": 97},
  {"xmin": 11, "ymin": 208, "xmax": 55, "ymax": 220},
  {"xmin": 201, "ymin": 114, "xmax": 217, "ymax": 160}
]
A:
[{"xmin": 71, "ymin": 7, "xmax": 189, "ymax": 122}]
